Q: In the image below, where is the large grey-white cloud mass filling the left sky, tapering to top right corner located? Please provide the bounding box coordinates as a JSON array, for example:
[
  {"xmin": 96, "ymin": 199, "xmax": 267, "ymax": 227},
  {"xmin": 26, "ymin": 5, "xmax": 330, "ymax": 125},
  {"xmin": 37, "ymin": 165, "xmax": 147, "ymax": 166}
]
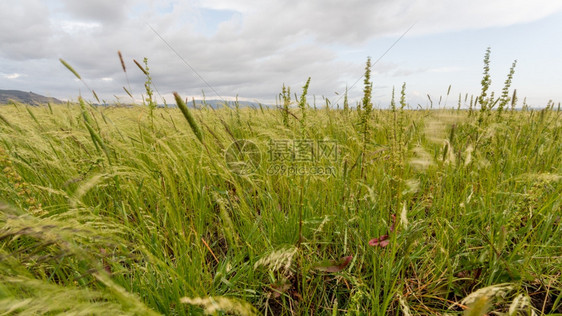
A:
[{"xmin": 0, "ymin": 0, "xmax": 562, "ymax": 105}]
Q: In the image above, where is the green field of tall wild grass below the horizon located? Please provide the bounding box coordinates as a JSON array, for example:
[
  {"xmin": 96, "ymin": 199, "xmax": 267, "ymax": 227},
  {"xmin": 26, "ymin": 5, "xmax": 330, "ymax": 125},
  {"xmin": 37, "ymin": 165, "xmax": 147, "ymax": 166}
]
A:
[{"xmin": 0, "ymin": 91, "xmax": 562, "ymax": 315}]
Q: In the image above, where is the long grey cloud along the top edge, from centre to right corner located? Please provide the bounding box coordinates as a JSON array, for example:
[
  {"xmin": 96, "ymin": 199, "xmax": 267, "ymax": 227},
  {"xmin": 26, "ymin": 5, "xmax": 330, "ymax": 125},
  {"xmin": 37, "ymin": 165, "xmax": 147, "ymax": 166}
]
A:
[{"xmin": 205, "ymin": 0, "xmax": 562, "ymax": 44}]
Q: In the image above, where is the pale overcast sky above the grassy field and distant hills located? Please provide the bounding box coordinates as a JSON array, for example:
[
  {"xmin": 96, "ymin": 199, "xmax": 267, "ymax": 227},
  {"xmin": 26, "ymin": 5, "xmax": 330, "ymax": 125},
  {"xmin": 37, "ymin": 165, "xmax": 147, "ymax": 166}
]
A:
[{"xmin": 0, "ymin": 0, "xmax": 562, "ymax": 108}]
